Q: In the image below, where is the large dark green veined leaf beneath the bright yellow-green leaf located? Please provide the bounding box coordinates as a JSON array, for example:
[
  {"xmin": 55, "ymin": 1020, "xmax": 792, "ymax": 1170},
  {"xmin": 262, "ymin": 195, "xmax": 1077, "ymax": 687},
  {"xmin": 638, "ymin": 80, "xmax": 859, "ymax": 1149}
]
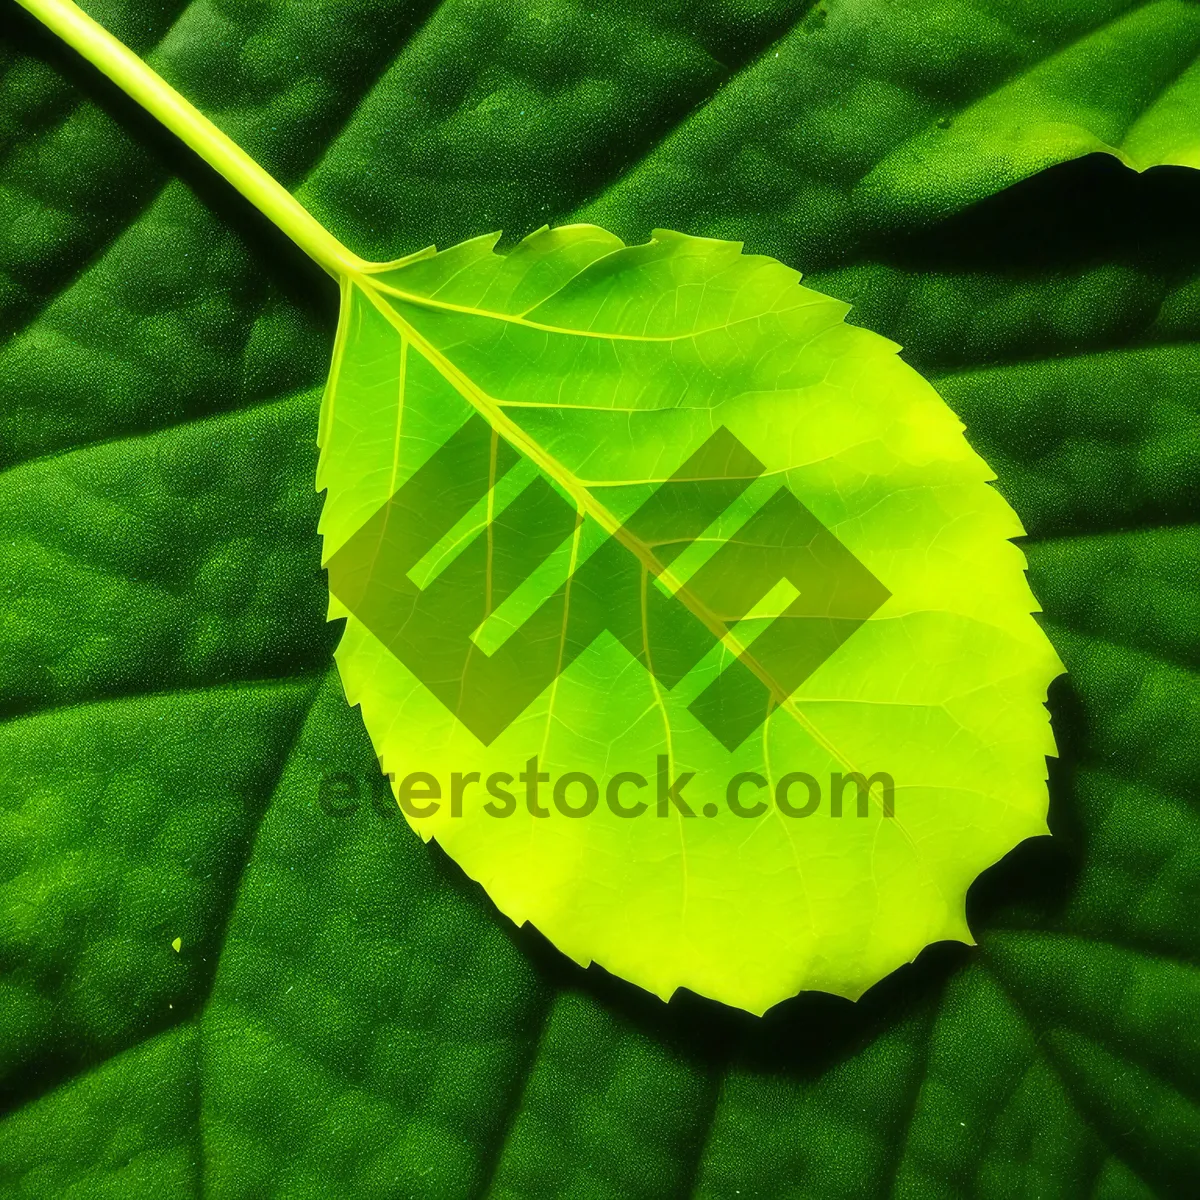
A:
[{"xmin": 0, "ymin": 0, "xmax": 1200, "ymax": 1200}]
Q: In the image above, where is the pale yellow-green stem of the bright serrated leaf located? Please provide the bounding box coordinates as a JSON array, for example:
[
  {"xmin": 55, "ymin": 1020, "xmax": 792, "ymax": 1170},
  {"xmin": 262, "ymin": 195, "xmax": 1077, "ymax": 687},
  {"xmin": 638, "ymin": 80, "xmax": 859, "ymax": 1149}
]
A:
[{"xmin": 17, "ymin": 0, "xmax": 368, "ymax": 278}]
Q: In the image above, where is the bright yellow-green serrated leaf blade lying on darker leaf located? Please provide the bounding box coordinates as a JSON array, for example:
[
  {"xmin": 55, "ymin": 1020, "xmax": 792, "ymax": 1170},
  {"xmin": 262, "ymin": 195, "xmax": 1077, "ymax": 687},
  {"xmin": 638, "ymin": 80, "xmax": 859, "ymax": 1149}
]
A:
[{"xmin": 318, "ymin": 226, "xmax": 1060, "ymax": 1013}]
